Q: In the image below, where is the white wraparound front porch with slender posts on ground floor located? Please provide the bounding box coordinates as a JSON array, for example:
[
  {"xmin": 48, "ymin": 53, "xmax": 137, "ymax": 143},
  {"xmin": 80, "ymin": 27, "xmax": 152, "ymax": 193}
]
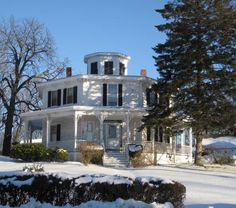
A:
[{"xmin": 23, "ymin": 108, "xmax": 192, "ymax": 163}]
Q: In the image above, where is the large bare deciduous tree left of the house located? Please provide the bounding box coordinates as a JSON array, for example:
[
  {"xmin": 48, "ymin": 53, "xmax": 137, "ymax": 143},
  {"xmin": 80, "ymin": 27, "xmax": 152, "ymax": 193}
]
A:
[{"xmin": 0, "ymin": 17, "xmax": 64, "ymax": 155}]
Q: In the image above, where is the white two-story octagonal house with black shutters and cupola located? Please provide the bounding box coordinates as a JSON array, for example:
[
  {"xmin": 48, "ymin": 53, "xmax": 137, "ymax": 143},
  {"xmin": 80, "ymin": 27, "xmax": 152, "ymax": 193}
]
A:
[{"xmin": 22, "ymin": 52, "xmax": 192, "ymax": 166}]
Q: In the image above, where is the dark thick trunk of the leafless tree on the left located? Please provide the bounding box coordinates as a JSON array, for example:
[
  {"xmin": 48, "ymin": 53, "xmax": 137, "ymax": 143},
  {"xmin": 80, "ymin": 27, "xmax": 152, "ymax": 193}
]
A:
[{"xmin": 2, "ymin": 99, "xmax": 15, "ymax": 156}]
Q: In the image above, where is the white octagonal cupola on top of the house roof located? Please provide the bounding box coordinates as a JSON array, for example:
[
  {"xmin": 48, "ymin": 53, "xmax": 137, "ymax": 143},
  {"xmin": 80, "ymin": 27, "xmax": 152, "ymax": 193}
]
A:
[{"xmin": 84, "ymin": 52, "xmax": 130, "ymax": 76}]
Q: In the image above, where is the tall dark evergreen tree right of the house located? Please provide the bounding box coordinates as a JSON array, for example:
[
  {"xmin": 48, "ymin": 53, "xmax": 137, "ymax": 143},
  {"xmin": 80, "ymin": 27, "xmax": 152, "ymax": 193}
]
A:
[{"xmin": 143, "ymin": 0, "xmax": 236, "ymax": 165}]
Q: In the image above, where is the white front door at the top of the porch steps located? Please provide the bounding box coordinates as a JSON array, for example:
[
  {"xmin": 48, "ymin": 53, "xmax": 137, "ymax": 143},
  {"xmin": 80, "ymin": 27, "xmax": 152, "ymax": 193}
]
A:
[{"xmin": 104, "ymin": 122, "xmax": 122, "ymax": 150}]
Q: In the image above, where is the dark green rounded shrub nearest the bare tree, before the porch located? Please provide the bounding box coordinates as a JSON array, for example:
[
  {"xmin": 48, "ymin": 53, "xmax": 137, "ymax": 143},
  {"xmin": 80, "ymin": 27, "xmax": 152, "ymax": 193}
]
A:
[{"xmin": 10, "ymin": 144, "xmax": 47, "ymax": 162}]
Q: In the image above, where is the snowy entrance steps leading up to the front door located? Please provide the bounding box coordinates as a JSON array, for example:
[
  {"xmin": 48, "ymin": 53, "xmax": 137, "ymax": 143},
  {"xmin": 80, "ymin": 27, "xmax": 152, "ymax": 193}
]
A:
[{"xmin": 103, "ymin": 151, "xmax": 129, "ymax": 167}]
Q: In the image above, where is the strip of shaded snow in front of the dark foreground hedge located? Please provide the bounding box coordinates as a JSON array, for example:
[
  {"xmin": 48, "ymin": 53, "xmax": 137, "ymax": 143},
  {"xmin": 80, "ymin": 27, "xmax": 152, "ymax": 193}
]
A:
[{"xmin": 0, "ymin": 198, "xmax": 174, "ymax": 208}]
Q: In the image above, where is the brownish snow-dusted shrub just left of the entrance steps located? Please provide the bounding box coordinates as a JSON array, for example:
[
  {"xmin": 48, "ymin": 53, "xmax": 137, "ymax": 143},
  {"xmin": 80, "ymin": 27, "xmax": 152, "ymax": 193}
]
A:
[{"xmin": 78, "ymin": 142, "xmax": 104, "ymax": 165}]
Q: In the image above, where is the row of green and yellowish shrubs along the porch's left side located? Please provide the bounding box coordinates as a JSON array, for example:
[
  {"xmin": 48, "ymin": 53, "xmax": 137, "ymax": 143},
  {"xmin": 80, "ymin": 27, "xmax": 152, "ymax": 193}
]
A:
[{"xmin": 10, "ymin": 144, "xmax": 68, "ymax": 162}]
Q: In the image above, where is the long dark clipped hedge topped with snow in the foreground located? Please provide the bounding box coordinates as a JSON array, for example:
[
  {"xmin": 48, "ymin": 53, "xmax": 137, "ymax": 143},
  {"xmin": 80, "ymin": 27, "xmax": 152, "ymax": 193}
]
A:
[{"xmin": 0, "ymin": 174, "xmax": 186, "ymax": 208}]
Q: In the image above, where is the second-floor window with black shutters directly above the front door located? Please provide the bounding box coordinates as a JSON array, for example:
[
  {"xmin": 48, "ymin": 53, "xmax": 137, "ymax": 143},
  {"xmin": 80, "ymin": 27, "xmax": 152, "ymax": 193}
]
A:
[{"xmin": 103, "ymin": 84, "xmax": 122, "ymax": 106}]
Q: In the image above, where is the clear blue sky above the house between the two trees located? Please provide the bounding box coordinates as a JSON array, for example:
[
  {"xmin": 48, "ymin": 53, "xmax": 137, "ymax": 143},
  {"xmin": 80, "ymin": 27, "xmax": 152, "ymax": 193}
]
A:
[{"xmin": 0, "ymin": 0, "xmax": 167, "ymax": 78}]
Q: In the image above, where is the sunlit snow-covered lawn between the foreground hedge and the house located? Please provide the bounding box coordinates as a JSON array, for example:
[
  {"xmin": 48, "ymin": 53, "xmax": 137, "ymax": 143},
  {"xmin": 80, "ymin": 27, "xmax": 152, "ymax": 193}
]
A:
[{"xmin": 0, "ymin": 156, "xmax": 236, "ymax": 208}]
